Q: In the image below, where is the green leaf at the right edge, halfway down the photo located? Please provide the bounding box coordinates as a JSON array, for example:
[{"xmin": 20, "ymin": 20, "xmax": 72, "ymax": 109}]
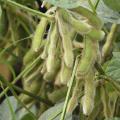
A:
[{"xmin": 105, "ymin": 52, "xmax": 120, "ymax": 81}]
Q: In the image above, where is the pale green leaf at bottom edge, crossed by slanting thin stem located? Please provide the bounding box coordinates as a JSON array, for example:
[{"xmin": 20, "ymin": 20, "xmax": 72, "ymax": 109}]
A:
[{"xmin": 39, "ymin": 102, "xmax": 72, "ymax": 120}]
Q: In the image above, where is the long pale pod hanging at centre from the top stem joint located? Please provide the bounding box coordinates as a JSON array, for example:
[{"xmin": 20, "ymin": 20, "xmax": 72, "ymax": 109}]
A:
[{"xmin": 56, "ymin": 11, "xmax": 74, "ymax": 68}]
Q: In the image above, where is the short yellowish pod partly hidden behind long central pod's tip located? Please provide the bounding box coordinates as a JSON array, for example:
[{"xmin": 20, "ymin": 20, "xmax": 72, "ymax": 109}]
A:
[{"xmin": 60, "ymin": 61, "xmax": 72, "ymax": 85}]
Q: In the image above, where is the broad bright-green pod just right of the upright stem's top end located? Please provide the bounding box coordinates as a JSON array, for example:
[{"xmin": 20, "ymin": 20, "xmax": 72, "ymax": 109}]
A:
[{"xmin": 76, "ymin": 36, "xmax": 98, "ymax": 78}]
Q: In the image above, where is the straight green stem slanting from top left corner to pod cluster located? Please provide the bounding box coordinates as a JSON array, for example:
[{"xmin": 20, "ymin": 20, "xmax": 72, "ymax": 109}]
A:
[{"xmin": 4, "ymin": 0, "xmax": 54, "ymax": 21}]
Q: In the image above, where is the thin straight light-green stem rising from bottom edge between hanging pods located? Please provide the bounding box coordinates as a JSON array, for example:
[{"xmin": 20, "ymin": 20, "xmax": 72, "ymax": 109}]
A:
[{"xmin": 60, "ymin": 57, "xmax": 79, "ymax": 120}]
